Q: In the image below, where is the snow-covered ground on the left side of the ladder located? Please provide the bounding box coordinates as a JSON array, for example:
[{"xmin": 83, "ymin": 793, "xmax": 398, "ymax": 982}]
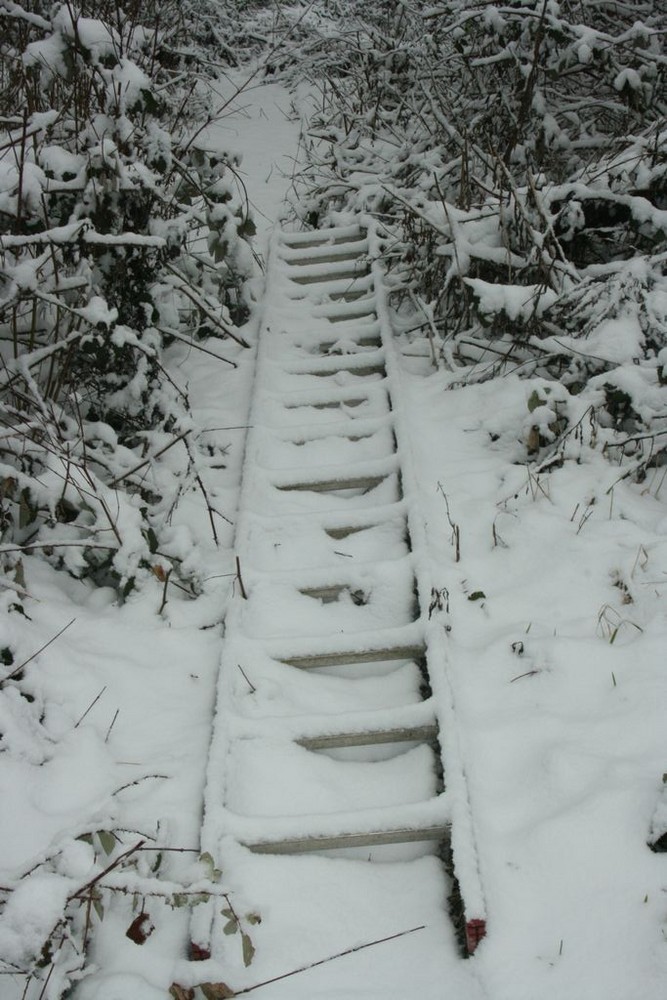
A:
[{"xmin": 0, "ymin": 81, "xmax": 299, "ymax": 1000}]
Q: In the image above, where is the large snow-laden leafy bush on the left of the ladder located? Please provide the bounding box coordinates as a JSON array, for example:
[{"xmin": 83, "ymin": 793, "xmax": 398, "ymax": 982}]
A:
[{"xmin": 0, "ymin": 0, "xmax": 254, "ymax": 590}]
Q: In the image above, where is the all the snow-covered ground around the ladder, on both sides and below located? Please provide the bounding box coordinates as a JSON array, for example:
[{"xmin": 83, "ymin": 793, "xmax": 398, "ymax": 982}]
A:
[{"xmin": 0, "ymin": 66, "xmax": 667, "ymax": 1000}]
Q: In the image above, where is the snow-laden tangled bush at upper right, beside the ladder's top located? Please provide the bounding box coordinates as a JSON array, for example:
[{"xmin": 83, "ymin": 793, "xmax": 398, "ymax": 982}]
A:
[{"xmin": 302, "ymin": 0, "xmax": 667, "ymax": 460}]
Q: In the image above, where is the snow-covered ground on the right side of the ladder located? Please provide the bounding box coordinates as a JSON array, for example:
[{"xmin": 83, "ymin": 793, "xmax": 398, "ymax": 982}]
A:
[{"xmin": 396, "ymin": 359, "xmax": 667, "ymax": 1000}]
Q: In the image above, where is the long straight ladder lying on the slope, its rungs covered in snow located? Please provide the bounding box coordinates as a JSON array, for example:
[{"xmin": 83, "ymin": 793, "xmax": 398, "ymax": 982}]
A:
[{"xmin": 193, "ymin": 219, "xmax": 485, "ymax": 976}]
